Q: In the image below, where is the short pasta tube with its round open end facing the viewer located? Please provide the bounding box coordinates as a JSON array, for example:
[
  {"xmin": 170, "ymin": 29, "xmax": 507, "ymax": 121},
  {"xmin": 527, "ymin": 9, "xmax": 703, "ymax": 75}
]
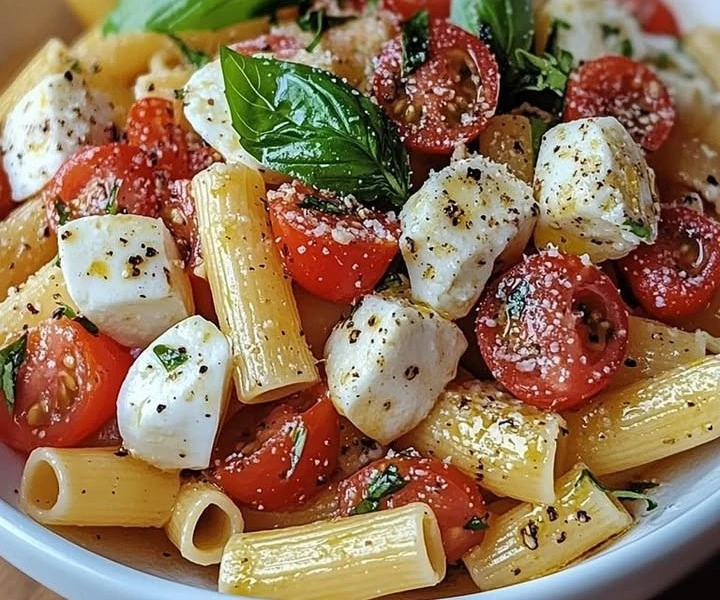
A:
[{"xmin": 165, "ymin": 483, "xmax": 244, "ymax": 566}]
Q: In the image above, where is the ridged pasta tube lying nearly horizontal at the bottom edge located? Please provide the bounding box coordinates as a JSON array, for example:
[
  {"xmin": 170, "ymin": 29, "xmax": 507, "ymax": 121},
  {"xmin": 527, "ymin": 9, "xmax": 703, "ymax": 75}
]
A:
[{"xmin": 218, "ymin": 504, "xmax": 446, "ymax": 600}]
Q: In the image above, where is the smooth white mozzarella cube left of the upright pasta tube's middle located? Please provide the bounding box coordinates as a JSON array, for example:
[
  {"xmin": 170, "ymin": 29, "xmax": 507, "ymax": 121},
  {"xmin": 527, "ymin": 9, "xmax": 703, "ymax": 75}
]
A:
[{"xmin": 58, "ymin": 215, "xmax": 194, "ymax": 348}]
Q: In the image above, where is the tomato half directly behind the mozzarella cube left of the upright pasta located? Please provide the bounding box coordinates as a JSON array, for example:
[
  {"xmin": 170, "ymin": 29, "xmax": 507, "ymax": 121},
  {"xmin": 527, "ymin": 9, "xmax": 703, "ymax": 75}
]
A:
[{"xmin": 44, "ymin": 144, "xmax": 166, "ymax": 229}]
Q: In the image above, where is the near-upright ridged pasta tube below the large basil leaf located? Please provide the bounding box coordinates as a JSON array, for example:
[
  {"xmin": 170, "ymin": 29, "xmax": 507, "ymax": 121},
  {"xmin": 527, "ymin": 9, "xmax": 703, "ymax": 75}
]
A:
[{"xmin": 193, "ymin": 163, "xmax": 319, "ymax": 404}]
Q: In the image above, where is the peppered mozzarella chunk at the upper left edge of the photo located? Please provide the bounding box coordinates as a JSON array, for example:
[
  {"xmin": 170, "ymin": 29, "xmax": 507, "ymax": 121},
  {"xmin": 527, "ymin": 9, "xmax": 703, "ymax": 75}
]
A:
[{"xmin": 0, "ymin": 71, "xmax": 114, "ymax": 202}]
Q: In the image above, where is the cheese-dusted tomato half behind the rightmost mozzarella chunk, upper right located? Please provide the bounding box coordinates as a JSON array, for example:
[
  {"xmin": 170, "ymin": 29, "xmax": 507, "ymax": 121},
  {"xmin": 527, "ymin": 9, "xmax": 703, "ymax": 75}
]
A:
[{"xmin": 564, "ymin": 56, "xmax": 676, "ymax": 151}]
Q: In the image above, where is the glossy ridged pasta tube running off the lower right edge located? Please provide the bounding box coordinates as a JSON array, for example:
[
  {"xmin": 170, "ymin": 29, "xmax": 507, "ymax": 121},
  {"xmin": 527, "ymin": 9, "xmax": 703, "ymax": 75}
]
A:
[{"xmin": 566, "ymin": 357, "xmax": 720, "ymax": 475}]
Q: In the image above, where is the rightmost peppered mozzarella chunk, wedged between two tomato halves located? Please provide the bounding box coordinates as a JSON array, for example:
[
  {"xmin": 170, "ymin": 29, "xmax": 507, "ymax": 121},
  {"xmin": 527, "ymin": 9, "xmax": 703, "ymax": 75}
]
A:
[{"xmin": 535, "ymin": 117, "xmax": 660, "ymax": 262}]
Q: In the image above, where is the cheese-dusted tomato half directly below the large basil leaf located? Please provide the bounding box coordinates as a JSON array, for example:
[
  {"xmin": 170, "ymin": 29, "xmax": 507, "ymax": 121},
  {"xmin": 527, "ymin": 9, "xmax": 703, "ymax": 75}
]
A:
[{"xmin": 268, "ymin": 182, "xmax": 400, "ymax": 303}]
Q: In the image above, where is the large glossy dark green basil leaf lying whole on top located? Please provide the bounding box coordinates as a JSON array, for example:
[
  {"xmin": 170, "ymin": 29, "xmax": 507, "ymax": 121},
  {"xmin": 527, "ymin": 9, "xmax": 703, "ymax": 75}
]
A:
[{"xmin": 220, "ymin": 48, "xmax": 410, "ymax": 207}]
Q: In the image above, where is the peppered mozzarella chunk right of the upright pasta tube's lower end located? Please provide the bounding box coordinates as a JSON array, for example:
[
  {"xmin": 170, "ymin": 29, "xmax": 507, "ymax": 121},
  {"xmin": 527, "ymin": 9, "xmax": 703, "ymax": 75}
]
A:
[{"xmin": 325, "ymin": 295, "xmax": 467, "ymax": 444}]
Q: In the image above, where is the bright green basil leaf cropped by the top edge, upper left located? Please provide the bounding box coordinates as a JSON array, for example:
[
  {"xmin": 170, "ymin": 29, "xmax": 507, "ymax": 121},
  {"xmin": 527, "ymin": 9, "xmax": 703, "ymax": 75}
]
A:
[{"xmin": 103, "ymin": 0, "xmax": 297, "ymax": 34}]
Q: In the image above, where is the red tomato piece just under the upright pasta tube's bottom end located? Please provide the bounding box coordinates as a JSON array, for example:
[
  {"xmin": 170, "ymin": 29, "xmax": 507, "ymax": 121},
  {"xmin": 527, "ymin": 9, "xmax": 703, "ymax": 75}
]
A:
[{"xmin": 211, "ymin": 386, "xmax": 340, "ymax": 510}]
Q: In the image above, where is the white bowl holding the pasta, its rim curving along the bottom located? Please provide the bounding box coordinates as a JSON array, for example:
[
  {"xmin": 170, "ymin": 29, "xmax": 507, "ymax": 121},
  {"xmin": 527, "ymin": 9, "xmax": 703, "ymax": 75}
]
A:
[{"xmin": 0, "ymin": 0, "xmax": 720, "ymax": 600}]
